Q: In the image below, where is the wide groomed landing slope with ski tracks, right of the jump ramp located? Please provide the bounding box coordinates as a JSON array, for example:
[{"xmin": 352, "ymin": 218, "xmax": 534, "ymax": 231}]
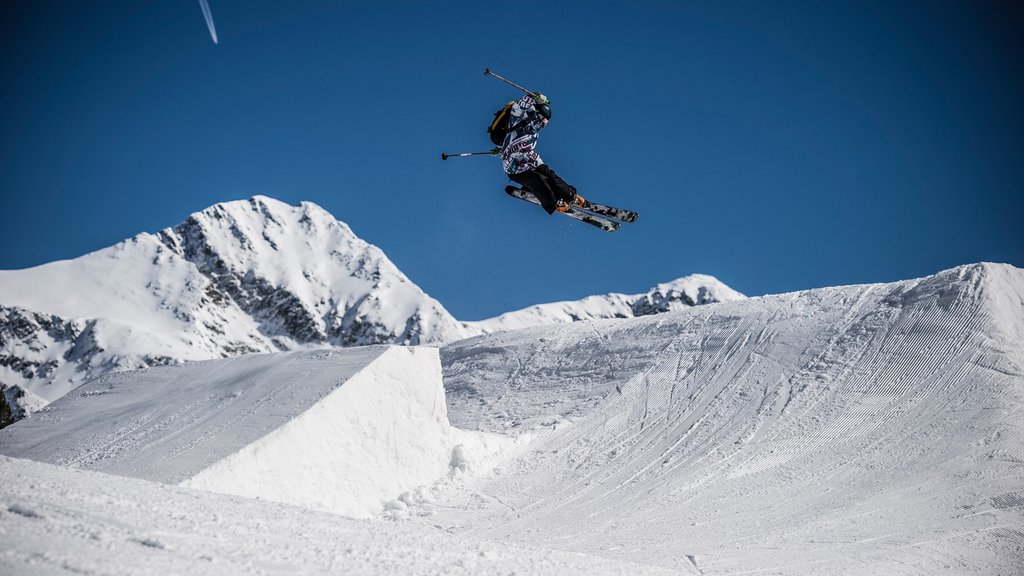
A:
[{"xmin": 440, "ymin": 264, "xmax": 1024, "ymax": 576}]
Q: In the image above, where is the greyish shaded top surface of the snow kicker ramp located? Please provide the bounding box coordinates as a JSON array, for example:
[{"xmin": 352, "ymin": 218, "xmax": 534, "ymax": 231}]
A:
[{"xmin": 0, "ymin": 346, "xmax": 386, "ymax": 484}]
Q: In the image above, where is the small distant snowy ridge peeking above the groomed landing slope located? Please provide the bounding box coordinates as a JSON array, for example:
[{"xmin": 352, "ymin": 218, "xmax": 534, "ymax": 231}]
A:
[{"xmin": 466, "ymin": 274, "xmax": 744, "ymax": 334}]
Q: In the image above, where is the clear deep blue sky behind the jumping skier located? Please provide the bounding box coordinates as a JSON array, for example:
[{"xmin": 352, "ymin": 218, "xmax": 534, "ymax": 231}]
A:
[{"xmin": 0, "ymin": 0, "xmax": 1024, "ymax": 320}]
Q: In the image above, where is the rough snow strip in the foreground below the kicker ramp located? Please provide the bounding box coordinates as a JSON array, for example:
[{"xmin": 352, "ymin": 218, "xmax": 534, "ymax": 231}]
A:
[{"xmin": 0, "ymin": 456, "xmax": 684, "ymax": 576}]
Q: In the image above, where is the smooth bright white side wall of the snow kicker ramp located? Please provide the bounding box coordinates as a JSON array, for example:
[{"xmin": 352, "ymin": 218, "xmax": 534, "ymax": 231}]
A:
[{"xmin": 183, "ymin": 347, "xmax": 454, "ymax": 518}]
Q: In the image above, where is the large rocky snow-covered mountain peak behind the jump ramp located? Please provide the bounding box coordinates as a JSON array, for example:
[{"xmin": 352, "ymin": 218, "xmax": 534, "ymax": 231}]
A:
[{"xmin": 0, "ymin": 196, "xmax": 469, "ymax": 411}]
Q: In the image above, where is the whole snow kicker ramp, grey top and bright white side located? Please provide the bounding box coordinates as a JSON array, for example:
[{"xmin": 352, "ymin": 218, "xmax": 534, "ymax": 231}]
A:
[{"xmin": 0, "ymin": 346, "xmax": 453, "ymax": 517}]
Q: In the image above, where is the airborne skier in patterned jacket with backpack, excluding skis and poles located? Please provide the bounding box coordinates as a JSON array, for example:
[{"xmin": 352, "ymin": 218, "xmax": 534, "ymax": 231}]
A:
[{"xmin": 499, "ymin": 92, "xmax": 583, "ymax": 214}]
